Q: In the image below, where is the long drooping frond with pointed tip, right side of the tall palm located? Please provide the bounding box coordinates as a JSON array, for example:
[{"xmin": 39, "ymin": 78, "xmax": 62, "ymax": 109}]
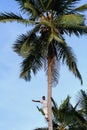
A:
[{"xmin": 58, "ymin": 44, "xmax": 83, "ymax": 84}]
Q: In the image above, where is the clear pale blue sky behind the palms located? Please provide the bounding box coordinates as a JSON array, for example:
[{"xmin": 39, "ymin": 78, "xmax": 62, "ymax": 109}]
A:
[{"xmin": 0, "ymin": 0, "xmax": 87, "ymax": 130}]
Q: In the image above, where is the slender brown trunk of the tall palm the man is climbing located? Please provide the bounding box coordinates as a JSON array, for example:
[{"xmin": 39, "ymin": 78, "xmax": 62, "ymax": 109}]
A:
[{"xmin": 48, "ymin": 58, "xmax": 53, "ymax": 130}]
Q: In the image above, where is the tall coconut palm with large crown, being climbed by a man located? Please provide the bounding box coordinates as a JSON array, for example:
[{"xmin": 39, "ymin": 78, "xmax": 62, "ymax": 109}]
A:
[{"xmin": 0, "ymin": 0, "xmax": 87, "ymax": 130}]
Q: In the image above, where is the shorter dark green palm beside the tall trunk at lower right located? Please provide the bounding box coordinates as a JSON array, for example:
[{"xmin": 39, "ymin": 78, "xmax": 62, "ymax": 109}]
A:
[{"xmin": 53, "ymin": 96, "xmax": 87, "ymax": 130}]
